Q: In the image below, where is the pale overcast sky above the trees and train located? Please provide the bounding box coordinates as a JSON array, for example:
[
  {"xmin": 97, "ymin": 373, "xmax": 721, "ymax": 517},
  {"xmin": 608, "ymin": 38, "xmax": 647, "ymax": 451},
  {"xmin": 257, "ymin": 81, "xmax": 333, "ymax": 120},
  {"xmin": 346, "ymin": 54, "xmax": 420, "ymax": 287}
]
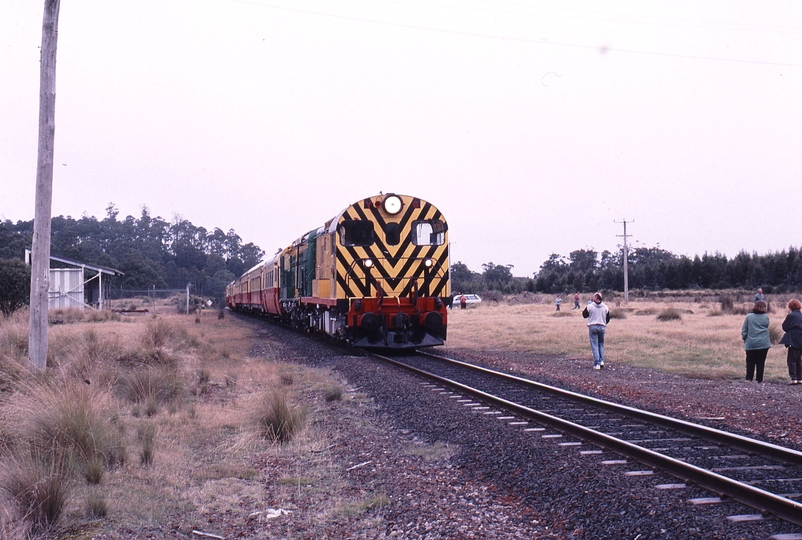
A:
[{"xmin": 0, "ymin": 0, "xmax": 802, "ymax": 275}]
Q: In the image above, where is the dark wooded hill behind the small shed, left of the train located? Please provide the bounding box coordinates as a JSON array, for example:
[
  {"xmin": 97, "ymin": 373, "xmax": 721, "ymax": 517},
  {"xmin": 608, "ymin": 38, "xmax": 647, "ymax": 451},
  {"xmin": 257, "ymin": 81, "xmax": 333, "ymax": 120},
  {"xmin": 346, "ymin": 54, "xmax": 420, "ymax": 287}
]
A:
[{"xmin": 0, "ymin": 204, "xmax": 264, "ymax": 299}]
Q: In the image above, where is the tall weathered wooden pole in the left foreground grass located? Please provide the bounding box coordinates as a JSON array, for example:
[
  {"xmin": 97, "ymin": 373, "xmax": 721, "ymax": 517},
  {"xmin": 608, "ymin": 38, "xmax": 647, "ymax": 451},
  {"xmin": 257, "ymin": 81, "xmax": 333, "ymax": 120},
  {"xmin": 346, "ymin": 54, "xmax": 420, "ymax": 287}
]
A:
[{"xmin": 28, "ymin": 0, "xmax": 60, "ymax": 369}]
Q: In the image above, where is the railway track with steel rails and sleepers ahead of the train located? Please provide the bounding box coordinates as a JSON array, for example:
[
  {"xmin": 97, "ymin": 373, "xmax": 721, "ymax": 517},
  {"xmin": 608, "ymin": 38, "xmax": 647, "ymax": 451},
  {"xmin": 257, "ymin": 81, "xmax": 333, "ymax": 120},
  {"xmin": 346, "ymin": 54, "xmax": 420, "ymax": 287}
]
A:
[{"xmin": 373, "ymin": 352, "xmax": 802, "ymax": 528}]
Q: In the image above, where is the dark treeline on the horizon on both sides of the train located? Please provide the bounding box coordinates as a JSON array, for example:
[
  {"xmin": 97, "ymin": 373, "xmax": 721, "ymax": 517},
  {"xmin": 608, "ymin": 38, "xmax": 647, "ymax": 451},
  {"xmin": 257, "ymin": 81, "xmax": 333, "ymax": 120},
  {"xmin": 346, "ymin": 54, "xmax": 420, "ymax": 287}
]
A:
[{"xmin": 0, "ymin": 208, "xmax": 802, "ymax": 299}]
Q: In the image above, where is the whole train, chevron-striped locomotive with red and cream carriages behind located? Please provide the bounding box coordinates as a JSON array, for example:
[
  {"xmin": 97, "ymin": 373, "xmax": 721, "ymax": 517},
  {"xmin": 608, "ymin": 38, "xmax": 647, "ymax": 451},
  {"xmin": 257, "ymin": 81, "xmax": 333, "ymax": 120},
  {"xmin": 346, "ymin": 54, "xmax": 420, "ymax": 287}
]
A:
[{"xmin": 226, "ymin": 193, "xmax": 451, "ymax": 349}]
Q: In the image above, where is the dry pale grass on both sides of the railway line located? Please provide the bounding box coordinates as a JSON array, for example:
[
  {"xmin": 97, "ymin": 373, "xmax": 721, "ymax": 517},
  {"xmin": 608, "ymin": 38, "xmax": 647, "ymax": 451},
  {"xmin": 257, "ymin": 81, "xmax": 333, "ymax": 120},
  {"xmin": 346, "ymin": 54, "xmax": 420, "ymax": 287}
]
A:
[{"xmin": 0, "ymin": 296, "xmax": 787, "ymax": 538}]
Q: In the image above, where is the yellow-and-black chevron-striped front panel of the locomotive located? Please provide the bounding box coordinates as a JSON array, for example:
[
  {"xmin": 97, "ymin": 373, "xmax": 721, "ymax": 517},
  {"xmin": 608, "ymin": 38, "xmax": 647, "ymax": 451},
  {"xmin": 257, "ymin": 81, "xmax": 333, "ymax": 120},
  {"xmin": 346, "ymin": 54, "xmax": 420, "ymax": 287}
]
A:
[{"xmin": 336, "ymin": 195, "xmax": 450, "ymax": 298}]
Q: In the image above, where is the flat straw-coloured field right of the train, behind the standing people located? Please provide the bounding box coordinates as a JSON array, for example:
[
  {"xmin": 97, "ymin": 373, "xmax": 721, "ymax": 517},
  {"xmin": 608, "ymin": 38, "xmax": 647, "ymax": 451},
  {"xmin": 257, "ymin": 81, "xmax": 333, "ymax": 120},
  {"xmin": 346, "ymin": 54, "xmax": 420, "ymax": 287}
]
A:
[{"xmin": 447, "ymin": 300, "xmax": 788, "ymax": 381}]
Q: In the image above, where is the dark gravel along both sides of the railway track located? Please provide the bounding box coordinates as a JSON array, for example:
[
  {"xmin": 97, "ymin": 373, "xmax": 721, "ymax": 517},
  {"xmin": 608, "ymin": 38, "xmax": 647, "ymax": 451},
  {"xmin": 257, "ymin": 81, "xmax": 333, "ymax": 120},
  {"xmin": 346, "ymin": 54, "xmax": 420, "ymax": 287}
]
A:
[{"xmin": 245, "ymin": 323, "xmax": 802, "ymax": 539}]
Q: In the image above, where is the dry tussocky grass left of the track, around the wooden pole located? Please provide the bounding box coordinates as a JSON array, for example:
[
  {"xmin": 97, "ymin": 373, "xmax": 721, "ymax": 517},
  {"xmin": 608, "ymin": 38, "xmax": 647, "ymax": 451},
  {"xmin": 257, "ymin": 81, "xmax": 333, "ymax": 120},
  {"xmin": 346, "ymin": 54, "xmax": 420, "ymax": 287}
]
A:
[{"xmin": 0, "ymin": 309, "xmax": 354, "ymax": 538}]
